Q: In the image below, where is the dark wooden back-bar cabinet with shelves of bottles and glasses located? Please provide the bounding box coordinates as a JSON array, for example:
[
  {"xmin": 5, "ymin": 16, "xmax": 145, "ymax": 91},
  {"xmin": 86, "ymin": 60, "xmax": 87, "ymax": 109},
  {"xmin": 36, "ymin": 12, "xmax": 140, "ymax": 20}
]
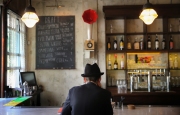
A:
[{"xmin": 103, "ymin": 4, "xmax": 180, "ymax": 104}]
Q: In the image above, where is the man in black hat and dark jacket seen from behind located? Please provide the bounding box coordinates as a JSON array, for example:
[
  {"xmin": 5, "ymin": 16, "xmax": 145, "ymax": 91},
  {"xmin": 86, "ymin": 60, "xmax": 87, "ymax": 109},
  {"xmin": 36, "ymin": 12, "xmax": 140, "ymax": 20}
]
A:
[{"xmin": 61, "ymin": 63, "xmax": 113, "ymax": 115}]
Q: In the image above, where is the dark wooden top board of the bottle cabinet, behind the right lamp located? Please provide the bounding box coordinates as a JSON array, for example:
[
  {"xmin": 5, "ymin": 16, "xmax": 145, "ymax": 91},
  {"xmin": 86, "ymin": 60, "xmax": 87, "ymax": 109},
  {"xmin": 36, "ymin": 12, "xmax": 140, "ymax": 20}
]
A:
[{"xmin": 103, "ymin": 4, "xmax": 180, "ymax": 19}]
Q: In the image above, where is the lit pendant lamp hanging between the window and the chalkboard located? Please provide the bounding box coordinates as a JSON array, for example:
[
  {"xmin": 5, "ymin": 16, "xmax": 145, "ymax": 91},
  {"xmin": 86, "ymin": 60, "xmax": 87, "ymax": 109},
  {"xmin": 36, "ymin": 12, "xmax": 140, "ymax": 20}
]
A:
[{"xmin": 21, "ymin": 0, "xmax": 39, "ymax": 28}]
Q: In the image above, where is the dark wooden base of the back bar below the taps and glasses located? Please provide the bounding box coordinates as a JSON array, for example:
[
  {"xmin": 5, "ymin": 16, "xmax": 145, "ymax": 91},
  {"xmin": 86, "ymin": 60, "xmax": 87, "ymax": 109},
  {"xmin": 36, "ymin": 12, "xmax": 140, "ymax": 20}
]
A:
[{"xmin": 107, "ymin": 87, "xmax": 180, "ymax": 105}]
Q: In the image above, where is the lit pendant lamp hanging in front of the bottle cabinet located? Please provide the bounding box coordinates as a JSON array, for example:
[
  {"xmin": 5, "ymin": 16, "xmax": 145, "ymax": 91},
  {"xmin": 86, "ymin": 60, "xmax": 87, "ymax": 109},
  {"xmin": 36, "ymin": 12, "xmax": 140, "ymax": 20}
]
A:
[{"xmin": 139, "ymin": 0, "xmax": 158, "ymax": 25}]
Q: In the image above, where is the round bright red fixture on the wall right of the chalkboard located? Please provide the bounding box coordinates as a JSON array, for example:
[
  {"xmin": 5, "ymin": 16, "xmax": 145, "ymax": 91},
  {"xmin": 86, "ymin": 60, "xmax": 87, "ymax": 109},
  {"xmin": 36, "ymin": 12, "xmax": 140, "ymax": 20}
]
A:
[{"xmin": 82, "ymin": 9, "xmax": 98, "ymax": 24}]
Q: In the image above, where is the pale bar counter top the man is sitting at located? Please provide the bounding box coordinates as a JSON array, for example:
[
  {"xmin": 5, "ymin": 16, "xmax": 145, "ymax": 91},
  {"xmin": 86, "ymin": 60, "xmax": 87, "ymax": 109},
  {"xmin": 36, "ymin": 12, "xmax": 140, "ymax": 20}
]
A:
[{"xmin": 0, "ymin": 98, "xmax": 180, "ymax": 115}]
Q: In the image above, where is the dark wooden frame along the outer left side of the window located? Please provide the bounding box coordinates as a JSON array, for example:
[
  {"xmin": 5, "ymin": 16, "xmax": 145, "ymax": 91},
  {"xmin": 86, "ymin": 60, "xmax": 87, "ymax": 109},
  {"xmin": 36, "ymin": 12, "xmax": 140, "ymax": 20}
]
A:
[{"xmin": 0, "ymin": 0, "xmax": 27, "ymax": 98}]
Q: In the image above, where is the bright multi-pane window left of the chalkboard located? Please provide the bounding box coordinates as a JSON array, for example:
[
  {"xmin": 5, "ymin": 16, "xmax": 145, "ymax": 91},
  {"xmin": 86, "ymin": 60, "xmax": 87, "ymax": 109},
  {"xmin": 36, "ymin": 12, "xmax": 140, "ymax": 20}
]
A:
[{"xmin": 7, "ymin": 10, "xmax": 26, "ymax": 88}]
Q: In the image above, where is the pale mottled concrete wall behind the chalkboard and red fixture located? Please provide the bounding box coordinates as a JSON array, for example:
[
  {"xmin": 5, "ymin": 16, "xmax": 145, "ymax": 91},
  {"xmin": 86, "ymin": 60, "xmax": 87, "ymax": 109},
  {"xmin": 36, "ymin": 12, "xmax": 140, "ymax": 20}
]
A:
[{"xmin": 27, "ymin": 0, "xmax": 180, "ymax": 106}]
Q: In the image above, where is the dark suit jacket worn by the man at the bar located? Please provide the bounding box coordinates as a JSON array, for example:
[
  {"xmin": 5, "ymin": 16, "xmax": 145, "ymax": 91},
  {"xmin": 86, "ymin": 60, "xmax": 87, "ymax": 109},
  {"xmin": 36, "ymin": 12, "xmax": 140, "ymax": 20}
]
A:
[{"xmin": 61, "ymin": 82, "xmax": 113, "ymax": 115}]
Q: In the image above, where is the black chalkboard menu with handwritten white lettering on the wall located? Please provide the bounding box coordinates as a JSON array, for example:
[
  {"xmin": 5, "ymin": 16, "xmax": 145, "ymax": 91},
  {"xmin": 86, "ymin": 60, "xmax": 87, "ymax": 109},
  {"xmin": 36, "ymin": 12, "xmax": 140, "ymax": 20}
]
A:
[{"xmin": 36, "ymin": 16, "xmax": 75, "ymax": 69}]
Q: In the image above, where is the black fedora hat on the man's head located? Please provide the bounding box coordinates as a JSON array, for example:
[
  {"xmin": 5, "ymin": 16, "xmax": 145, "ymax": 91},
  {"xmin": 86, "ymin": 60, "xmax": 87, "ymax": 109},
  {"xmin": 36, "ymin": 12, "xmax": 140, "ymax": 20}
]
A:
[{"xmin": 81, "ymin": 63, "xmax": 104, "ymax": 77}]
